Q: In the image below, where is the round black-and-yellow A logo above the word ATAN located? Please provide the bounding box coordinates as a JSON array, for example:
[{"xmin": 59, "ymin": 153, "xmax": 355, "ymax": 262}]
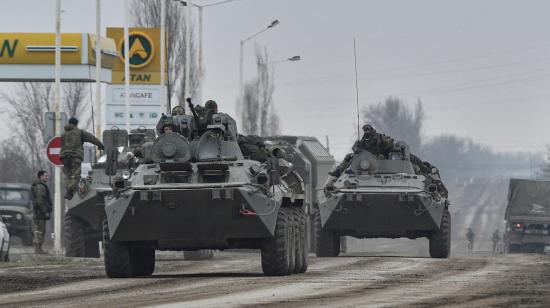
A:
[{"xmin": 119, "ymin": 32, "xmax": 155, "ymax": 68}]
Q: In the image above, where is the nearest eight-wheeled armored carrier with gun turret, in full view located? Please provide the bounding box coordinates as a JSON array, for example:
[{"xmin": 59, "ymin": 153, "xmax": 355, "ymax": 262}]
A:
[{"xmin": 103, "ymin": 107, "xmax": 307, "ymax": 277}]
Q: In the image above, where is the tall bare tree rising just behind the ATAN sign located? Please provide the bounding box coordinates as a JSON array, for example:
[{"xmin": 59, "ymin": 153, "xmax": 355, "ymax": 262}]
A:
[{"xmin": 130, "ymin": 0, "xmax": 200, "ymax": 105}]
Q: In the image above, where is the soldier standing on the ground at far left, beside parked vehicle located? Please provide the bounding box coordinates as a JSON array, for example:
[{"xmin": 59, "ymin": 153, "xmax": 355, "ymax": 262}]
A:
[{"xmin": 31, "ymin": 170, "xmax": 52, "ymax": 254}]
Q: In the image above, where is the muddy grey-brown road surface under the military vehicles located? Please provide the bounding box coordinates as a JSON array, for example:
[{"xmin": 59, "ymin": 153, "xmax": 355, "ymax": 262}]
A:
[{"xmin": 0, "ymin": 252, "xmax": 550, "ymax": 307}]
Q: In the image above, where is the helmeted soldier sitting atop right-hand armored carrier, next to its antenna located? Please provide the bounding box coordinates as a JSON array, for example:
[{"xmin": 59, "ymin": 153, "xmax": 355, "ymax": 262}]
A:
[{"xmin": 329, "ymin": 124, "xmax": 394, "ymax": 177}]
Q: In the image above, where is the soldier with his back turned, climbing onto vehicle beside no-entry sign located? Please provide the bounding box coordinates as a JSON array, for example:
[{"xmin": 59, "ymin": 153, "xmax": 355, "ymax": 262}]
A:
[{"xmin": 61, "ymin": 118, "xmax": 104, "ymax": 200}]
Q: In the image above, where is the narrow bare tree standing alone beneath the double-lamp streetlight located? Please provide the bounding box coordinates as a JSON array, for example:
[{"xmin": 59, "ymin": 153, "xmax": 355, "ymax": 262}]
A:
[{"xmin": 241, "ymin": 46, "xmax": 280, "ymax": 136}]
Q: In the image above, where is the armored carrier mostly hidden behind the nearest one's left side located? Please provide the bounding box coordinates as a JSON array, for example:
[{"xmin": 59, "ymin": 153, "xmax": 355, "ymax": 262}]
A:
[{"xmin": 64, "ymin": 127, "xmax": 155, "ymax": 258}]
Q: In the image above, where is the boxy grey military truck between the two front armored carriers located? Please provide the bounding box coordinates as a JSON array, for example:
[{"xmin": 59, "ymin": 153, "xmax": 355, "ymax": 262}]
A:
[{"xmin": 263, "ymin": 135, "xmax": 335, "ymax": 249}]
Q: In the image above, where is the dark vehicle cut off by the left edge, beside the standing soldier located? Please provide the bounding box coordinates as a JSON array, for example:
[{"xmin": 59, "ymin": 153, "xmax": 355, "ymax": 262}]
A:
[{"xmin": 0, "ymin": 183, "xmax": 33, "ymax": 246}]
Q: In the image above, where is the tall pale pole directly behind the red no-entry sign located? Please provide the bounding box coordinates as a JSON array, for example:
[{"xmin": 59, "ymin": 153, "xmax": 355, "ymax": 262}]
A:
[{"xmin": 53, "ymin": 0, "xmax": 62, "ymax": 259}]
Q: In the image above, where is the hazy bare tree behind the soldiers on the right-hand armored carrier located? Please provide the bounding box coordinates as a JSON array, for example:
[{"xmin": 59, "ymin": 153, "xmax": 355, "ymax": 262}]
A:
[{"xmin": 362, "ymin": 96, "xmax": 426, "ymax": 152}]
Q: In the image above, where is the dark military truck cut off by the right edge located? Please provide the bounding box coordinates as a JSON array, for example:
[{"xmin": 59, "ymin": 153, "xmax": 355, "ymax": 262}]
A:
[{"xmin": 503, "ymin": 179, "xmax": 550, "ymax": 253}]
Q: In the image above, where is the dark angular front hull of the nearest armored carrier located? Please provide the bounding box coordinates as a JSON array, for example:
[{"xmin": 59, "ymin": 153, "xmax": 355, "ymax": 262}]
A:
[{"xmin": 106, "ymin": 172, "xmax": 283, "ymax": 250}]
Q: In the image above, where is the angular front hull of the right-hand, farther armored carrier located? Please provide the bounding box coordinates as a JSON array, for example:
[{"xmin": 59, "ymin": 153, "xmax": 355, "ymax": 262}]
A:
[{"xmin": 320, "ymin": 174, "xmax": 445, "ymax": 238}]
